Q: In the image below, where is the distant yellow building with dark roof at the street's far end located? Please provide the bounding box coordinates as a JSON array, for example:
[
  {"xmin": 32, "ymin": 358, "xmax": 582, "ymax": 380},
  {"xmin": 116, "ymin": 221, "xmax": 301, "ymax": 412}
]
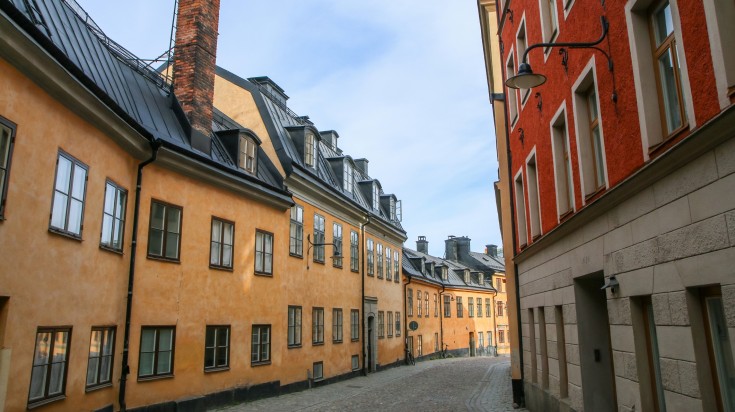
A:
[{"xmin": 403, "ymin": 236, "xmax": 508, "ymax": 358}]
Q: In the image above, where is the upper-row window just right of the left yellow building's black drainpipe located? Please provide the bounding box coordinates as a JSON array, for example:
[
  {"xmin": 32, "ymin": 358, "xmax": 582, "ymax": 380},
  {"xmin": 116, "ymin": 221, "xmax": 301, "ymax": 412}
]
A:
[{"xmin": 148, "ymin": 200, "xmax": 182, "ymax": 260}]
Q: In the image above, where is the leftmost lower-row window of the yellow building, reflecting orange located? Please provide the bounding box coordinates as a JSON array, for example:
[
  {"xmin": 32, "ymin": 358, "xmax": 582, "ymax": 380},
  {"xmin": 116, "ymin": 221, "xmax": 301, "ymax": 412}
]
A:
[{"xmin": 28, "ymin": 328, "xmax": 71, "ymax": 406}]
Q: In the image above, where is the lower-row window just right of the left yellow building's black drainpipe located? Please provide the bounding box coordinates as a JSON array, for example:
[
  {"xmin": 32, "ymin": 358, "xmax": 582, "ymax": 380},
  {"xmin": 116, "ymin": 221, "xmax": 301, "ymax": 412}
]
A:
[{"xmin": 138, "ymin": 326, "xmax": 176, "ymax": 378}]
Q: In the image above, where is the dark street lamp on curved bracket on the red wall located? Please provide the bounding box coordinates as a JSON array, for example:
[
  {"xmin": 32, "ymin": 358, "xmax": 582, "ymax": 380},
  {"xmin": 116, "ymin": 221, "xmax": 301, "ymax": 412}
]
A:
[{"xmin": 505, "ymin": 16, "xmax": 618, "ymax": 102}]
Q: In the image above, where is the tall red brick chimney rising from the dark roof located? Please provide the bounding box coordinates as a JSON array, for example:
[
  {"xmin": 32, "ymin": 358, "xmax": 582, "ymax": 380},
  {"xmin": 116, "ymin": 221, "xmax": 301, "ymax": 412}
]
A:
[{"xmin": 174, "ymin": 0, "xmax": 219, "ymax": 154}]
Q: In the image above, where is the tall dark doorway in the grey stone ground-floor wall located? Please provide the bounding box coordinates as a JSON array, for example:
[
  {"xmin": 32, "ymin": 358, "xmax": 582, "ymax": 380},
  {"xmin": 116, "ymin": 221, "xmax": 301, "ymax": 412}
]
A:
[{"xmin": 574, "ymin": 272, "xmax": 618, "ymax": 412}]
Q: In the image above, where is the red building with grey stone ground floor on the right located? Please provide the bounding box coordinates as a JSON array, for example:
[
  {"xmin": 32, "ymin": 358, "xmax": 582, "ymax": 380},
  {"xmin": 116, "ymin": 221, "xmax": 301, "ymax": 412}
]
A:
[{"xmin": 481, "ymin": 0, "xmax": 735, "ymax": 411}]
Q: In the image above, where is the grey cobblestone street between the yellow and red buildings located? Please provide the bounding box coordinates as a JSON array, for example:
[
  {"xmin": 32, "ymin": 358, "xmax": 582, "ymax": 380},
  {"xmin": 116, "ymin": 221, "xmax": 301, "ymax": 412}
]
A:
[{"xmin": 214, "ymin": 357, "xmax": 525, "ymax": 412}]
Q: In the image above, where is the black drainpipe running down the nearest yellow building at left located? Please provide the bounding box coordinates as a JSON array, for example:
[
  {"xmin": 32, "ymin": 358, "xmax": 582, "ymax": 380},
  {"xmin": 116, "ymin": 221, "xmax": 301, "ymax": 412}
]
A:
[{"xmin": 118, "ymin": 139, "xmax": 161, "ymax": 412}]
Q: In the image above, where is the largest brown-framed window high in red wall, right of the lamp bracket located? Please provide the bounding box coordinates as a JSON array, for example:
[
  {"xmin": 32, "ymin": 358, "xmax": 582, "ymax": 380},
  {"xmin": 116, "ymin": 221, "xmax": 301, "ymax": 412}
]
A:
[{"xmin": 651, "ymin": 1, "xmax": 686, "ymax": 136}]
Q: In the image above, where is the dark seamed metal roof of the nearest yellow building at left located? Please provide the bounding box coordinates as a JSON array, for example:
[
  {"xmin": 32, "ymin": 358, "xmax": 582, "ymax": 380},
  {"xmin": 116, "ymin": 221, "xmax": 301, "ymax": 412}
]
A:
[{"xmin": 6, "ymin": 0, "xmax": 290, "ymax": 197}]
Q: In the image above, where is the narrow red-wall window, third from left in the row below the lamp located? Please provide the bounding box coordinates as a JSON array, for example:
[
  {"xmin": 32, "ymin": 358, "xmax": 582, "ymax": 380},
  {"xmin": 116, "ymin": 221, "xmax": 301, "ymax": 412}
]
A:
[{"xmin": 551, "ymin": 106, "xmax": 574, "ymax": 217}]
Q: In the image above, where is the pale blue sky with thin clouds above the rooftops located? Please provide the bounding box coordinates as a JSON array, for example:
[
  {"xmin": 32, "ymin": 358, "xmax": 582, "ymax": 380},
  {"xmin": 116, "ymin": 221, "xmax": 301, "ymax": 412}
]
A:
[{"xmin": 77, "ymin": 0, "xmax": 502, "ymax": 256}]
